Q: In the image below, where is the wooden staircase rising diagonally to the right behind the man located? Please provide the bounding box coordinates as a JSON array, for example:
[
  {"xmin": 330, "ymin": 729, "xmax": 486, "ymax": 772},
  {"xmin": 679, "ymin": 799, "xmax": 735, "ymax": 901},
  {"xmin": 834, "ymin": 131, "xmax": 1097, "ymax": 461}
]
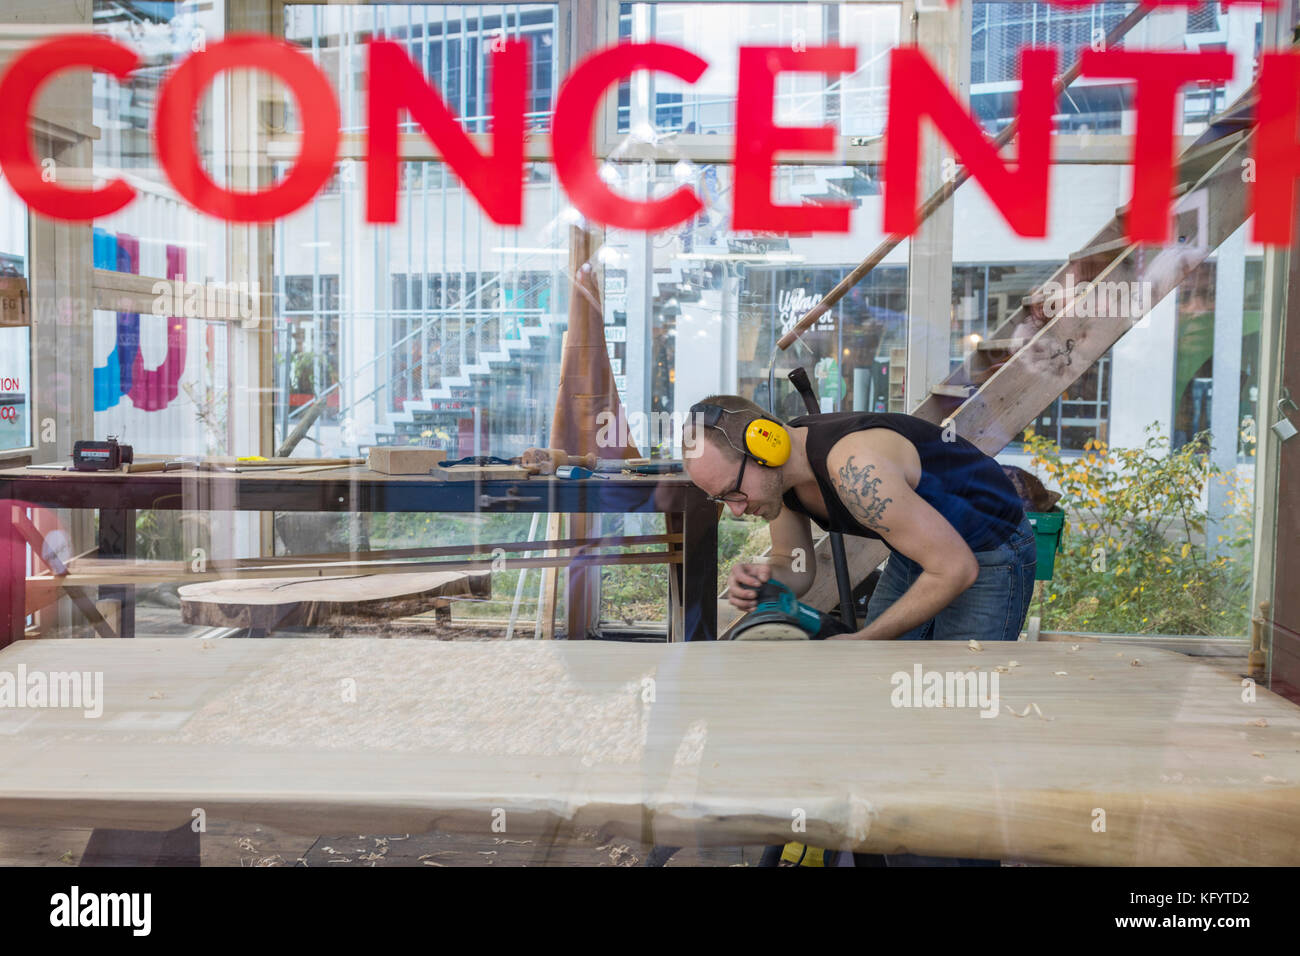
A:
[{"xmin": 780, "ymin": 87, "xmax": 1256, "ymax": 610}]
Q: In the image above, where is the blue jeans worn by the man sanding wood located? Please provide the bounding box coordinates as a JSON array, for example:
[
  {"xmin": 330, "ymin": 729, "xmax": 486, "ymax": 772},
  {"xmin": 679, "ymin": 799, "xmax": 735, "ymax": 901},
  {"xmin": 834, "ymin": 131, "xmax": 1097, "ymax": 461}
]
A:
[{"xmin": 866, "ymin": 518, "xmax": 1037, "ymax": 641}]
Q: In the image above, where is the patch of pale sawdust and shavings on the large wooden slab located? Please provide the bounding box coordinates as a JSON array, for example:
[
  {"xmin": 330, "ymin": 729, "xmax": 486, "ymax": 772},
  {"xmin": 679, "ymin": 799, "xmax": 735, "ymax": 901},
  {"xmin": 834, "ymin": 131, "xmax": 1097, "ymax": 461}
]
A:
[{"xmin": 85, "ymin": 641, "xmax": 707, "ymax": 766}]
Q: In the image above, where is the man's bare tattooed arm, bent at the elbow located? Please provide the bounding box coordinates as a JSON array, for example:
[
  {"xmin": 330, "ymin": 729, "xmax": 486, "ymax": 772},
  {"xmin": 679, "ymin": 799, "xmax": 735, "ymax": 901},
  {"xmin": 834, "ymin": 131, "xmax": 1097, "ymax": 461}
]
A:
[{"xmin": 827, "ymin": 433, "xmax": 979, "ymax": 640}]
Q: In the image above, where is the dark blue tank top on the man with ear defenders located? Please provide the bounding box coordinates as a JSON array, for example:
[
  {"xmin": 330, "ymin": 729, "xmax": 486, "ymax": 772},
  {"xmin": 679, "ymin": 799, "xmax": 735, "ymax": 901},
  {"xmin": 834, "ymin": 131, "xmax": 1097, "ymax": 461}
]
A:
[{"xmin": 783, "ymin": 412, "xmax": 1024, "ymax": 551}]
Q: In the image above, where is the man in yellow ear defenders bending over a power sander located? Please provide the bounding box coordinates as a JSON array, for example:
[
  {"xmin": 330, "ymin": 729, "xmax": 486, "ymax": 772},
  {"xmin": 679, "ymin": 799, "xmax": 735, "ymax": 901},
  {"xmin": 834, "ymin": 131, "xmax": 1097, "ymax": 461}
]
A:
[{"xmin": 684, "ymin": 395, "xmax": 1036, "ymax": 640}]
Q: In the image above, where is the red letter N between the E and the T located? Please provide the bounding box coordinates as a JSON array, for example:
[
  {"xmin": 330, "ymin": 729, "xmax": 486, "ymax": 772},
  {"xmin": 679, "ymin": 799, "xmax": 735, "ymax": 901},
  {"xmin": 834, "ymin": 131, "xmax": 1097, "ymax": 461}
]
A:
[{"xmin": 884, "ymin": 47, "xmax": 1056, "ymax": 237}]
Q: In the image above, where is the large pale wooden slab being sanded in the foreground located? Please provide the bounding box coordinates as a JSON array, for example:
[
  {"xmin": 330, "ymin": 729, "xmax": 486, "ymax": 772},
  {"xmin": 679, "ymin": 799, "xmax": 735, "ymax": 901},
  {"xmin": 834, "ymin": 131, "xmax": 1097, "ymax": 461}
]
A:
[{"xmin": 0, "ymin": 640, "xmax": 1300, "ymax": 864}]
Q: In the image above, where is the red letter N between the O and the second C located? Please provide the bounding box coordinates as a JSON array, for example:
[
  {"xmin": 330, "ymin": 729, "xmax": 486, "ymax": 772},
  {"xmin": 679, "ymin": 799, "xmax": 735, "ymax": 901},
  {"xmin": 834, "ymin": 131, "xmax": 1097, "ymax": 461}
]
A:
[{"xmin": 365, "ymin": 40, "xmax": 528, "ymax": 226}]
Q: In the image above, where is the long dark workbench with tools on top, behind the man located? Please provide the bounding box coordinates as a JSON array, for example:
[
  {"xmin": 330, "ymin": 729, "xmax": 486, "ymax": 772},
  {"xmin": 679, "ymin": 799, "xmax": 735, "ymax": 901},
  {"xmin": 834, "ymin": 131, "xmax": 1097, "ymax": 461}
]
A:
[{"xmin": 0, "ymin": 468, "xmax": 718, "ymax": 646}]
